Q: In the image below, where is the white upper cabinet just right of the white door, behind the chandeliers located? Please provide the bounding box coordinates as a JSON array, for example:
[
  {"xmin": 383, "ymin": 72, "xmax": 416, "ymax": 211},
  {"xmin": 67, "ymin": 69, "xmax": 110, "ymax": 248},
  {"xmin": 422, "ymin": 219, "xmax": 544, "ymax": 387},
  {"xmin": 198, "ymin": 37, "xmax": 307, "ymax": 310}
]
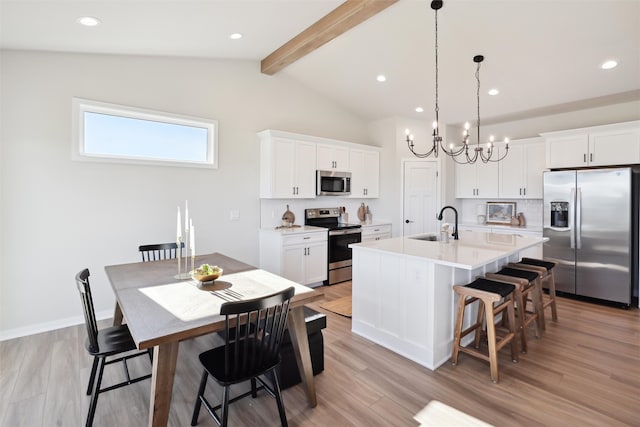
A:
[{"xmin": 455, "ymin": 159, "xmax": 499, "ymax": 199}]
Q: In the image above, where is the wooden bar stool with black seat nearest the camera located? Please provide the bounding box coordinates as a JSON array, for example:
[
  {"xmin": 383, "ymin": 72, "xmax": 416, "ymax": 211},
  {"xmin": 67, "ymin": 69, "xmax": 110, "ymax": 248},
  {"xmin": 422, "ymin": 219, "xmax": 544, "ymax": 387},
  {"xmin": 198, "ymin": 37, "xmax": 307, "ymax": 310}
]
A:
[{"xmin": 451, "ymin": 278, "xmax": 518, "ymax": 383}]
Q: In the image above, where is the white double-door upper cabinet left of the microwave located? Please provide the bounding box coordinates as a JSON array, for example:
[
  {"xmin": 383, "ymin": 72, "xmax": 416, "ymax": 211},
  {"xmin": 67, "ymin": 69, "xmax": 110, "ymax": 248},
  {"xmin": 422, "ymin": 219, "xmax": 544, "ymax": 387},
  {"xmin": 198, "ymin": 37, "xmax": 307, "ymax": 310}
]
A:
[{"xmin": 258, "ymin": 131, "xmax": 316, "ymax": 199}]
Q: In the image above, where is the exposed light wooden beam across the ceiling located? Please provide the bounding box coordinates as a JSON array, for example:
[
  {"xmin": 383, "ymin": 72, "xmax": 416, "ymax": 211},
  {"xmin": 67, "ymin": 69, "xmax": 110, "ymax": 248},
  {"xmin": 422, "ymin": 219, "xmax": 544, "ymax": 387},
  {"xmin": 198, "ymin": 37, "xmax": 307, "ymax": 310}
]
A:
[{"xmin": 260, "ymin": 0, "xmax": 398, "ymax": 75}]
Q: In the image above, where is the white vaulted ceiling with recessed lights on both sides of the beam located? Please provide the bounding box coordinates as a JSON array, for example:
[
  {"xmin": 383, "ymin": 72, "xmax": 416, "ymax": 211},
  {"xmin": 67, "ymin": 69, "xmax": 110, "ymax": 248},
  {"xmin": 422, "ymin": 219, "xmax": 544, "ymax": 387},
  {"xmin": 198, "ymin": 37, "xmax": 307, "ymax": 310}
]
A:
[{"xmin": 0, "ymin": 0, "xmax": 640, "ymax": 123}]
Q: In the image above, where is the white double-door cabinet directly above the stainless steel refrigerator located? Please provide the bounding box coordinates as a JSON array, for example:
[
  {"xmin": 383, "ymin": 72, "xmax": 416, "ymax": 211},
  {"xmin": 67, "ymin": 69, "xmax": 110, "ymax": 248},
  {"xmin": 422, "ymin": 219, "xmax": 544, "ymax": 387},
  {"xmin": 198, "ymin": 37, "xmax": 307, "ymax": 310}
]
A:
[{"xmin": 540, "ymin": 121, "xmax": 640, "ymax": 169}]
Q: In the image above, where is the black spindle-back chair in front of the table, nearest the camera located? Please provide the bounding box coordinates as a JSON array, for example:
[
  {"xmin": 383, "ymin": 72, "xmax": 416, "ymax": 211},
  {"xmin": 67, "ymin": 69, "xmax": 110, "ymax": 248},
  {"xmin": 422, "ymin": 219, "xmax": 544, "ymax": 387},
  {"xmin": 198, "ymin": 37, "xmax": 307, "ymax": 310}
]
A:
[{"xmin": 191, "ymin": 287, "xmax": 295, "ymax": 427}]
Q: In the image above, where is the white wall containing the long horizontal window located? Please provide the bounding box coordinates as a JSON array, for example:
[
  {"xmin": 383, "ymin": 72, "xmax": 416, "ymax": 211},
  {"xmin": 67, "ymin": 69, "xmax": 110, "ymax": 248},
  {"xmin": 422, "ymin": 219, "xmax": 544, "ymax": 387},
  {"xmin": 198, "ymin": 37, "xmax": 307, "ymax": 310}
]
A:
[{"xmin": 0, "ymin": 51, "xmax": 368, "ymax": 339}]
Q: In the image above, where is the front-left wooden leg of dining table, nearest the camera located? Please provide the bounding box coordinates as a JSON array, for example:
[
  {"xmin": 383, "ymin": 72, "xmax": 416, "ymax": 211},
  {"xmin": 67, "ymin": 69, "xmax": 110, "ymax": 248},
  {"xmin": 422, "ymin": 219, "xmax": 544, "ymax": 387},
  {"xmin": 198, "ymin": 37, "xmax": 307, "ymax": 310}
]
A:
[{"xmin": 149, "ymin": 342, "xmax": 179, "ymax": 427}]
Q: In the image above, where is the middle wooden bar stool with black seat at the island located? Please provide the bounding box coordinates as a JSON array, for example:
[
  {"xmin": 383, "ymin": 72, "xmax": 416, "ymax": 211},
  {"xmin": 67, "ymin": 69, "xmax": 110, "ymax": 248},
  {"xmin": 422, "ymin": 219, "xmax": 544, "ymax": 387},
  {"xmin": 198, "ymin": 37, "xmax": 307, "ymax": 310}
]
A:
[{"xmin": 485, "ymin": 267, "xmax": 544, "ymax": 353}]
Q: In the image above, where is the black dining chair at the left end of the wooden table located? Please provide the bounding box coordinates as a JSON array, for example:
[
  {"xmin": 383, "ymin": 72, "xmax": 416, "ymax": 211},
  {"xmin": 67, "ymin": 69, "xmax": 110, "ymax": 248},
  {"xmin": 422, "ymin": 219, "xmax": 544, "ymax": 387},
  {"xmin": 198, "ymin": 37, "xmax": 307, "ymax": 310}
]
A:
[{"xmin": 76, "ymin": 268, "xmax": 151, "ymax": 427}]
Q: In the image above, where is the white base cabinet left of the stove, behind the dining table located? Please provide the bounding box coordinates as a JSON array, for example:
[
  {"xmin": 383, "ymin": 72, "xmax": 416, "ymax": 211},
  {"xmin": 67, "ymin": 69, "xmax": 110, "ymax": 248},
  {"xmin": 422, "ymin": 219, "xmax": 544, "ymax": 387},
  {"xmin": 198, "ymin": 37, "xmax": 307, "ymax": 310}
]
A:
[{"xmin": 260, "ymin": 229, "xmax": 328, "ymax": 285}]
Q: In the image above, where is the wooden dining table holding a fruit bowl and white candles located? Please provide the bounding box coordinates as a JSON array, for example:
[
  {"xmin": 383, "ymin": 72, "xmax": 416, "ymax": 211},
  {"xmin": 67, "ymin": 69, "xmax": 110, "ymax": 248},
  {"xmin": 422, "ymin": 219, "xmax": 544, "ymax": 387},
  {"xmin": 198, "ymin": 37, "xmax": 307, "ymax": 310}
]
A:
[{"xmin": 105, "ymin": 253, "xmax": 323, "ymax": 427}]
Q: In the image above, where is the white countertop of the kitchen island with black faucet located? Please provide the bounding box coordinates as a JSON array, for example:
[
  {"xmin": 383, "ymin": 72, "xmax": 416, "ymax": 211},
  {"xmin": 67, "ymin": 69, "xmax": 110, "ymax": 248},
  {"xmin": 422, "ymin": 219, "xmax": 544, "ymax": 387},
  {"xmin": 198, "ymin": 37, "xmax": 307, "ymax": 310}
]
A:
[{"xmin": 349, "ymin": 231, "xmax": 545, "ymax": 270}]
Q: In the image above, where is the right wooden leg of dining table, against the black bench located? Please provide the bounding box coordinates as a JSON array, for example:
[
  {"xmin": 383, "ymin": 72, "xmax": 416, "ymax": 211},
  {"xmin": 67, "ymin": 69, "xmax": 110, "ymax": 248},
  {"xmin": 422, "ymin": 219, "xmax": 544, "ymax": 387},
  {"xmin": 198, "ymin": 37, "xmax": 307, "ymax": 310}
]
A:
[{"xmin": 289, "ymin": 306, "xmax": 318, "ymax": 408}]
